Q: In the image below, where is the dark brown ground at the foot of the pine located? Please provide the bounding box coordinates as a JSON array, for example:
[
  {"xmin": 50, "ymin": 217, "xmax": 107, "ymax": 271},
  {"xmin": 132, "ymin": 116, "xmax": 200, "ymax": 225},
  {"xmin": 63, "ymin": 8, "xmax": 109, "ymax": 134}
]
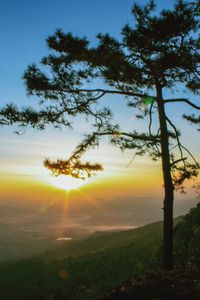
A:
[{"xmin": 103, "ymin": 270, "xmax": 200, "ymax": 300}]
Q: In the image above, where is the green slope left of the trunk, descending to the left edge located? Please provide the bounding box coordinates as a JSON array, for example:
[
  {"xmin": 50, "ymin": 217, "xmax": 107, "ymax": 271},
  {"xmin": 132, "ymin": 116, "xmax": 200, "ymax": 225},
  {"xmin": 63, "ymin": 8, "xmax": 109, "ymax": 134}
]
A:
[{"xmin": 0, "ymin": 218, "xmax": 182, "ymax": 300}]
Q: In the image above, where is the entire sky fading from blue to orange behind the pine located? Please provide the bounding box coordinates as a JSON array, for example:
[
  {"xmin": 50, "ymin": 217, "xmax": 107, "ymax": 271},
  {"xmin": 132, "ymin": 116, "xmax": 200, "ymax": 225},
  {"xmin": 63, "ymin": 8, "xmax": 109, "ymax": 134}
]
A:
[{"xmin": 0, "ymin": 0, "xmax": 199, "ymax": 230}]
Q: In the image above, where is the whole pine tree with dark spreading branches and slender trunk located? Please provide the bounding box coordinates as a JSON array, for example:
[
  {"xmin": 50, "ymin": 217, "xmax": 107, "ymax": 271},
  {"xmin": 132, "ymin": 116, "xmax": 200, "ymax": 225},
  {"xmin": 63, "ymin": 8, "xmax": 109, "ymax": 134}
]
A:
[{"xmin": 1, "ymin": 0, "xmax": 200, "ymax": 269}]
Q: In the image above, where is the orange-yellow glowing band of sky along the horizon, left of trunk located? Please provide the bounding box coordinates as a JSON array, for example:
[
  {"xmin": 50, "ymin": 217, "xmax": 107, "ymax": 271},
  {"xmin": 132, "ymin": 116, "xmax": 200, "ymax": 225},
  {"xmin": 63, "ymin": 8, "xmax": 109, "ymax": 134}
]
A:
[{"xmin": 0, "ymin": 168, "xmax": 163, "ymax": 206}]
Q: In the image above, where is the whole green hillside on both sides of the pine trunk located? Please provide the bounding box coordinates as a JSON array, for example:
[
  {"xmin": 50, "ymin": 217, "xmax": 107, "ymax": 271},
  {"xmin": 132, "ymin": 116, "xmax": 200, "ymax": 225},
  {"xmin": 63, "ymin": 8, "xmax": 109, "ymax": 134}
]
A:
[{"xmin": 0, "ymin": 205, "xmax": 200, "ymax": 300}]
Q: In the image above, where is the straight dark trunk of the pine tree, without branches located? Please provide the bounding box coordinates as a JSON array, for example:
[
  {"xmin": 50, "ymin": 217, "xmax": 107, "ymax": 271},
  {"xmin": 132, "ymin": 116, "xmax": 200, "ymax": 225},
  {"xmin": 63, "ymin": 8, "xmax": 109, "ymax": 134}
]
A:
[{"xmin": 157, "ymin": 85, "xmax": 174, "ymax": 270}]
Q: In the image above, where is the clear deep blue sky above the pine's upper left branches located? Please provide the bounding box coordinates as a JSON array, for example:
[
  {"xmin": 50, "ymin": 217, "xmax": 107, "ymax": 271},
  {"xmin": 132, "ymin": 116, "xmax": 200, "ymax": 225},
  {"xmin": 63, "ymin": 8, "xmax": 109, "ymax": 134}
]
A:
[{"xmin": 0, "ymin": 0, "xmax": 173, "ymax": 103}]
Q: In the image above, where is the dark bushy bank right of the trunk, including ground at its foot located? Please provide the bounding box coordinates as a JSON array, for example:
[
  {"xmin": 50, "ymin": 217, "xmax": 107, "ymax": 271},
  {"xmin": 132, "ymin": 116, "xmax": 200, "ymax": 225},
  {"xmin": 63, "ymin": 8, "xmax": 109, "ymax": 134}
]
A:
[{"xmin": 103, "ymin": 203, "xmax": 200, "ymax": 300}]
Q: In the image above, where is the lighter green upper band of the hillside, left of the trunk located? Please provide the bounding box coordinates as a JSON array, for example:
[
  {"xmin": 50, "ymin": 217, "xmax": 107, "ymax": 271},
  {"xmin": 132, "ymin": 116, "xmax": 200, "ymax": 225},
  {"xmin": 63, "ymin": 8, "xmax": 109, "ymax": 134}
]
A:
[{"xmin": 40, "ymin": 222, "xmax": 162, "ymax": 260}]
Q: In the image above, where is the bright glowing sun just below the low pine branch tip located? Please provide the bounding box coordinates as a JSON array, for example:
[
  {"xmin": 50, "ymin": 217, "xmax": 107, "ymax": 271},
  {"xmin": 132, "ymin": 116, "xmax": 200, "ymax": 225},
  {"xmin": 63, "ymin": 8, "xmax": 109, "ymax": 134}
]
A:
[{"xmin": 50, "ymin": 175, "xmax": 86, "ymax": 191}]
